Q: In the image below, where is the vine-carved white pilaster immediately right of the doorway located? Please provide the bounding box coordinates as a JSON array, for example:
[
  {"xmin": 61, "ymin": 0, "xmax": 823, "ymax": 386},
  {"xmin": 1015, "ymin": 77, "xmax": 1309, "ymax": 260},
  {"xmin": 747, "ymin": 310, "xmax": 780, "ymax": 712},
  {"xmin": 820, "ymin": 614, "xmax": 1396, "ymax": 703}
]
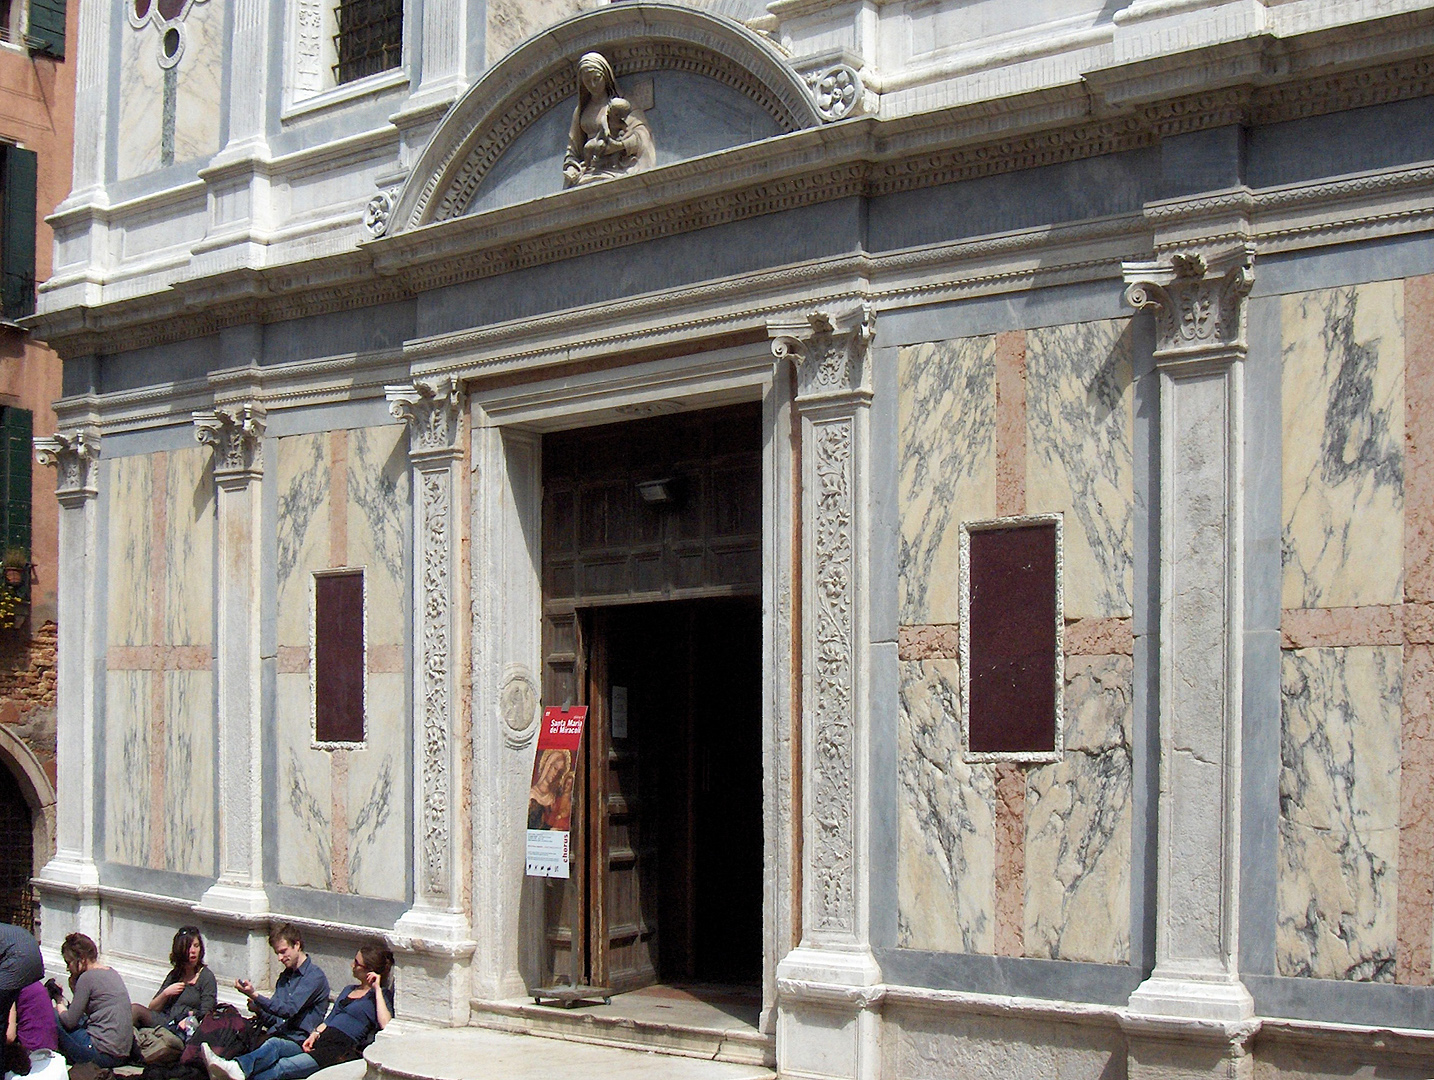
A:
[{"xmin": 767, "ymin": 304, "xmax": 880, "ymax": 1076}]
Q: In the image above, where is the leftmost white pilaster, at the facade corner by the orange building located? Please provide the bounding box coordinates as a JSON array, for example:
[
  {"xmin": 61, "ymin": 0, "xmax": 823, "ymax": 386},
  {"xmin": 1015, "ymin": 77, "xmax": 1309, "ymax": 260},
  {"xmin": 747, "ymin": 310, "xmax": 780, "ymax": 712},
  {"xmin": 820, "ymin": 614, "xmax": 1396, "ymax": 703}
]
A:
[{"xmin": 34, "ymin": 426, "xmax": 100, "ymax": 923}]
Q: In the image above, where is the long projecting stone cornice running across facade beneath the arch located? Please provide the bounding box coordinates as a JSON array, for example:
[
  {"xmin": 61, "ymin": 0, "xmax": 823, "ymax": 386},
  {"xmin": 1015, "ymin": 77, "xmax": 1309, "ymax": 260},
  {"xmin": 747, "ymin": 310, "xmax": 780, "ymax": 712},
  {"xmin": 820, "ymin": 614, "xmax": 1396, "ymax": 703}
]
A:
[{"xmin": 27, "ymin": 38, "xmax": 1434, "ymax": 356}]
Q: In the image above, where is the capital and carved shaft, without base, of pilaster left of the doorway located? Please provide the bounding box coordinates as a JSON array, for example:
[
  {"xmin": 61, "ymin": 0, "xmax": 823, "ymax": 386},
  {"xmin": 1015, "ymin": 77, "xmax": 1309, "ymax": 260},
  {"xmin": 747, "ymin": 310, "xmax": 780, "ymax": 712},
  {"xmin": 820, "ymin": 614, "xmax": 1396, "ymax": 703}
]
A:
[{"xmin": 386, "ymin": 379, "xmax": 460, "ymax": 905}]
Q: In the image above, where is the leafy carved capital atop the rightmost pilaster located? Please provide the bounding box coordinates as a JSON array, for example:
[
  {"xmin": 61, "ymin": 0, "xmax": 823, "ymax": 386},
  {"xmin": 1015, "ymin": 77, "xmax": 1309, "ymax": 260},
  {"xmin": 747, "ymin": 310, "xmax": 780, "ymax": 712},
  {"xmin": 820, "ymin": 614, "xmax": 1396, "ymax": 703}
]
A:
[{"xmin": 1123, "ymin": 247, "xmax": 1255, "ymax": 361}]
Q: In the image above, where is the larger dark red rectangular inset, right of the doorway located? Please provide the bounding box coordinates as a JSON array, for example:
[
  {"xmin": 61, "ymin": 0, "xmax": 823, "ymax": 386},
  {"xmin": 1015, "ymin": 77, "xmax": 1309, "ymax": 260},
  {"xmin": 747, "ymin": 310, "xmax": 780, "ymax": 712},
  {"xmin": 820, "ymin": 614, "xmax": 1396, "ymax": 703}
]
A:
[{"xmin": 968, "ymin": 522, "xmax": 1058, "ymax": 754}]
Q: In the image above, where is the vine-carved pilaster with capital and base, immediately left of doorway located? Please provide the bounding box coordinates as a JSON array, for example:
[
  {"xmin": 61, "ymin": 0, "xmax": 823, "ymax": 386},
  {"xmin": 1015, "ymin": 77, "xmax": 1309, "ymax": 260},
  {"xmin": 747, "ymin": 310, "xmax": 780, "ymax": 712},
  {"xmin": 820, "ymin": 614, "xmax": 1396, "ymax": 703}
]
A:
[{"xmin": 386, "ymin": 379, "xmax": 467, "ymax": 941}]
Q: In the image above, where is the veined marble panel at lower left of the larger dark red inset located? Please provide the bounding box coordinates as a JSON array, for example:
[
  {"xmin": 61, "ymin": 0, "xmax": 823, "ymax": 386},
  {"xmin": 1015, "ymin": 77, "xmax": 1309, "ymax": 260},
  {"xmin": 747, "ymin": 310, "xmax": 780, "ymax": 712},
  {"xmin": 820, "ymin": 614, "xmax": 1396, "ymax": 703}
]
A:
[{"xmin": 896, "ymin": 660, "xmax": 995, "ymax": 954}]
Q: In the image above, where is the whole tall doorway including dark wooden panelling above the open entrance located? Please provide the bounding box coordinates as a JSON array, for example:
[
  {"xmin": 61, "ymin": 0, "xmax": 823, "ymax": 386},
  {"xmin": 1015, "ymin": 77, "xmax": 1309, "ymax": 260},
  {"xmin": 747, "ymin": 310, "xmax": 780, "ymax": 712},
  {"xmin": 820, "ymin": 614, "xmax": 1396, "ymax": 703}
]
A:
[{"xmin": 542, "ymin": 404, "xmax": 764, "ymax": 993}]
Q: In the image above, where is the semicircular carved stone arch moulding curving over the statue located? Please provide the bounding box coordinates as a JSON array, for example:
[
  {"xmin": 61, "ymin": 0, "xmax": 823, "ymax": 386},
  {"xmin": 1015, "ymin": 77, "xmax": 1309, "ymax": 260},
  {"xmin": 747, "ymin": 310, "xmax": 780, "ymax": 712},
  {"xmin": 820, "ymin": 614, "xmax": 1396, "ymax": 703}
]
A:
[{"xmin": 387, "ymin": 3, "xmax": 822, "ymax": 235}]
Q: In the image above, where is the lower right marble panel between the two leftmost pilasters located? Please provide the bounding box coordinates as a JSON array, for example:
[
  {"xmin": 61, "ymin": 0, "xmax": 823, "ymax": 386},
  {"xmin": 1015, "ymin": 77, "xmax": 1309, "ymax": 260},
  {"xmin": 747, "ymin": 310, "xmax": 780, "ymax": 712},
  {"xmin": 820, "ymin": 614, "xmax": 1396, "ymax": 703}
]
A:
[{"xmin": 163, "ymin": 671, "xmax": 218, "ymax": 875}]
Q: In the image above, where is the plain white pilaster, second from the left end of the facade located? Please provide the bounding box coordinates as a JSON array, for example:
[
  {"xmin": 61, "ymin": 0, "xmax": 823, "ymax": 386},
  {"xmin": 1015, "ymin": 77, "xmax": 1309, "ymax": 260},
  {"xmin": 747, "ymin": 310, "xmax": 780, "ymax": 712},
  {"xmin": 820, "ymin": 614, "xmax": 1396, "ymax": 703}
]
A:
[{"xmin": 192, "ymin": 402, "xmax": 268, "ymax": 915}]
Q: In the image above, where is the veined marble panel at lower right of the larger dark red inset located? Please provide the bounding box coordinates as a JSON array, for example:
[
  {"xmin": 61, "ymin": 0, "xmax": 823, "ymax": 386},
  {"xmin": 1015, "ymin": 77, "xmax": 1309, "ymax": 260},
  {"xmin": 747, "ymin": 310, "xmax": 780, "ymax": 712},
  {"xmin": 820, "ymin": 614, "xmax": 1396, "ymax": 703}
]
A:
[{"xmin": 1025, "ymin": 657, "xmax": 1134, "ymax": 964}]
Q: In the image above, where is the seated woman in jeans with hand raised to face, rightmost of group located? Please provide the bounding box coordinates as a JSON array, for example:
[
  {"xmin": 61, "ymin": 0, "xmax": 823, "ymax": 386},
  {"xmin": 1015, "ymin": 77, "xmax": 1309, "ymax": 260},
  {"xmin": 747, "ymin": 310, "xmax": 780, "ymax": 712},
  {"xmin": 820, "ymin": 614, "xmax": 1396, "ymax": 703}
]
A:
[{"xmin": 201, "ymin": 941, "xmax": 393, "ymax": 1080}]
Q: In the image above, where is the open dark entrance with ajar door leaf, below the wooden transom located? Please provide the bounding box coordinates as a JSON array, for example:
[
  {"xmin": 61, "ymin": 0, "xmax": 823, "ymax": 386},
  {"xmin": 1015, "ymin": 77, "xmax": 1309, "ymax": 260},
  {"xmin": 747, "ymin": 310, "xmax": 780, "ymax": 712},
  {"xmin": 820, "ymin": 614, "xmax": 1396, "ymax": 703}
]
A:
[{"xmin": 584, "ymin": 598, "xmax": 761, "ymax": 991}]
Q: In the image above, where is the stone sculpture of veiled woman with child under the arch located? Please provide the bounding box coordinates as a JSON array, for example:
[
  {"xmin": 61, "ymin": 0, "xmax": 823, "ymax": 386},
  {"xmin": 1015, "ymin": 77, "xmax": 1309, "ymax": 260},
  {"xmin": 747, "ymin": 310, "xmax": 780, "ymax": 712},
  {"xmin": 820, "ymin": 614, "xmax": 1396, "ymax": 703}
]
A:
[{"xmin": 562, "ymin": 53, "xmax": 657, "ymax": 188}]
